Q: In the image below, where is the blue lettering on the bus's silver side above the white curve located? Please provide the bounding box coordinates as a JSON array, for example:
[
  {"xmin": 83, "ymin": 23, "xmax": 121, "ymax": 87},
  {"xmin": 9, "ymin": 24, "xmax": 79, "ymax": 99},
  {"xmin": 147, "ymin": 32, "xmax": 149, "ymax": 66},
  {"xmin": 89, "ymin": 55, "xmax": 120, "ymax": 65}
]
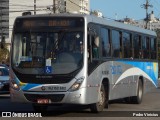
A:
[{"xmin": 110, "ymin": 65, "xmax": 122, "ymax": 75}]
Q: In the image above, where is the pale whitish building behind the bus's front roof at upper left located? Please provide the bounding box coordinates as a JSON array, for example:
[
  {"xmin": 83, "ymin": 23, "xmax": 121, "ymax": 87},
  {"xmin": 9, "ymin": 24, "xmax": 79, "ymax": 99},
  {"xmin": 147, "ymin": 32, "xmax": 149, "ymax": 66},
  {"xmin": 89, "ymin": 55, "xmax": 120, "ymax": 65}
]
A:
[{"xmin": 9, "ymin": 0, "xmax": 53, "ymax": 41}]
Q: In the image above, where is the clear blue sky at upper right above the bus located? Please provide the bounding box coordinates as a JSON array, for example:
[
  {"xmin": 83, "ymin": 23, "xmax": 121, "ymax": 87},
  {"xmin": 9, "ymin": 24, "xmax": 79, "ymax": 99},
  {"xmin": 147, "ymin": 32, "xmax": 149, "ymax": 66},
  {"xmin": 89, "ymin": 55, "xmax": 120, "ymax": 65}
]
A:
[{"xmin": 90, "ymin": 0, "xmax": 160, "ymax": 20}]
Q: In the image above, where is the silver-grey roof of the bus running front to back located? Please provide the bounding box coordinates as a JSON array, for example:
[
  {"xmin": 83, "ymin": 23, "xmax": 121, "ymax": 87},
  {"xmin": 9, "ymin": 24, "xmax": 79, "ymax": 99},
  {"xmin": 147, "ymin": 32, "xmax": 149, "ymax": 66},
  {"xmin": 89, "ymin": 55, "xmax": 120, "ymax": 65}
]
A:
[{"xmin": 17, "ymin": 13, "xmax": 157, "ymax": 36}]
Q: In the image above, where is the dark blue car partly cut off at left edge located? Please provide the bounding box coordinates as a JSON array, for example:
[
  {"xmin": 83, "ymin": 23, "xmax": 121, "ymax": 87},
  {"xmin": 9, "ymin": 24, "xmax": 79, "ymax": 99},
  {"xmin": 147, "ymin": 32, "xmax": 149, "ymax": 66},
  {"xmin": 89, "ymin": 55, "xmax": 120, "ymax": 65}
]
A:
[{"xmin": 0, "ymin": 66, "xmax": 9, "ymax": 94}]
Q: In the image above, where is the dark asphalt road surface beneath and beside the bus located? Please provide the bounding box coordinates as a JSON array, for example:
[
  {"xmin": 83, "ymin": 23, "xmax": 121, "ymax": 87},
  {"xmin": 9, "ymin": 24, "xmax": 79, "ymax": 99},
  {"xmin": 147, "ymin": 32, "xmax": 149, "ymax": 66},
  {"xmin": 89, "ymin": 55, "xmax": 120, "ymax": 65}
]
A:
[{"xmin": 0, "ymin": 88, "xmax": 160, "ymax": 117}]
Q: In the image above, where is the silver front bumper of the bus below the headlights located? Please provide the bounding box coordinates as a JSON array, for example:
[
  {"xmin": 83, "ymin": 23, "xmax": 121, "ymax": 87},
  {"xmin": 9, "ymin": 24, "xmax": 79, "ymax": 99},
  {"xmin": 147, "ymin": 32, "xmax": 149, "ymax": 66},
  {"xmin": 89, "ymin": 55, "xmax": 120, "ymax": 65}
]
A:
[{"xmin": 10, "ymin": 88, "xmax": 87, "ymax": 104}]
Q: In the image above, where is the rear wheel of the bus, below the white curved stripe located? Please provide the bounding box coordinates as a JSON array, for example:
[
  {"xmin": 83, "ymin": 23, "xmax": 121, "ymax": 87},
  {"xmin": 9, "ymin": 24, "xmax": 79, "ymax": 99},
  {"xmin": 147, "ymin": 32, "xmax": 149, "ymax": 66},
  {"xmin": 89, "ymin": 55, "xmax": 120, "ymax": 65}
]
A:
[{"xmin": 131, "ymin": 79, "xmax": 143, "ymax": 104}]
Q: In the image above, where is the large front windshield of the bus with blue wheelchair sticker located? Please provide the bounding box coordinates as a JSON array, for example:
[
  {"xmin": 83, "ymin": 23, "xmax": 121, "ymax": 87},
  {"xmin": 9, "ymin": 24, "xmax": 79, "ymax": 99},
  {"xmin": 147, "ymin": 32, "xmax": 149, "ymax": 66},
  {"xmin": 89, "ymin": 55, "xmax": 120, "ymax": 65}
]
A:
[{"xmin": 12, "ymin": 17, "xmax": 84, "ymax": 74}]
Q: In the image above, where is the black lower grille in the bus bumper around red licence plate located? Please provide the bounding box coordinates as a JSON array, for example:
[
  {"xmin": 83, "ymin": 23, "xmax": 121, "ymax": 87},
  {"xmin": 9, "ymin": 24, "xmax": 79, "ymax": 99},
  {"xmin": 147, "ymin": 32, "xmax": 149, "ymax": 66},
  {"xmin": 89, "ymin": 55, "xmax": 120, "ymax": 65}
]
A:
[{"xmin": 24, "ymin": 94, "xmax": 64, "ymax": 102}]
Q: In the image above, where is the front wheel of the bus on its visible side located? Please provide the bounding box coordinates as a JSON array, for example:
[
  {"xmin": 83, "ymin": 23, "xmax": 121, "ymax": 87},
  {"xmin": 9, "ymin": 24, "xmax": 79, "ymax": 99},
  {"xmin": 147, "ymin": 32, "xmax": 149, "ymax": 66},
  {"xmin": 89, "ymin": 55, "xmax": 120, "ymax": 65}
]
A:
[{"xmin": 90, "ymin": 84, "xmax": 106, "ymax": 113}]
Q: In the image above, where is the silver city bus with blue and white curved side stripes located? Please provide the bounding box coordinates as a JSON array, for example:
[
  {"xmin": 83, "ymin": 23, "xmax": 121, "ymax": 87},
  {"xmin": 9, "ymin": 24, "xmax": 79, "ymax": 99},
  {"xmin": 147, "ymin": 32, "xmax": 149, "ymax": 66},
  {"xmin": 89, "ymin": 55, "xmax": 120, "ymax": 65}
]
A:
[{"xmin": 10, "ymin": 13, "xmax": 158, "ymax": 112}]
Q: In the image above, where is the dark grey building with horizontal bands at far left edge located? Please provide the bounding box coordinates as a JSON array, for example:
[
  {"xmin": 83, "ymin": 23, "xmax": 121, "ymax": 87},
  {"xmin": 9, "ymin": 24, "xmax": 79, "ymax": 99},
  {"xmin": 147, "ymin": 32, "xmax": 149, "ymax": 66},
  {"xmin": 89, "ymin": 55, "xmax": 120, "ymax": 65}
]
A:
[{"xmin": 0, "ymin": 0, "xmax": 9, "ymax": 42}]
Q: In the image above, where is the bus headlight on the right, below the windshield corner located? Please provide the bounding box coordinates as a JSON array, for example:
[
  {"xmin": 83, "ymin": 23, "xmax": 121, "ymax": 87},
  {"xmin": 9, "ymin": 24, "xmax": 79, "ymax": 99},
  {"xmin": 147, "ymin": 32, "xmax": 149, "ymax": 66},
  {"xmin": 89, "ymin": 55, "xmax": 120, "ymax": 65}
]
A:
[{"xmin": 69, "ymin": 77, "xmax": 84, "ymax": 92}]
